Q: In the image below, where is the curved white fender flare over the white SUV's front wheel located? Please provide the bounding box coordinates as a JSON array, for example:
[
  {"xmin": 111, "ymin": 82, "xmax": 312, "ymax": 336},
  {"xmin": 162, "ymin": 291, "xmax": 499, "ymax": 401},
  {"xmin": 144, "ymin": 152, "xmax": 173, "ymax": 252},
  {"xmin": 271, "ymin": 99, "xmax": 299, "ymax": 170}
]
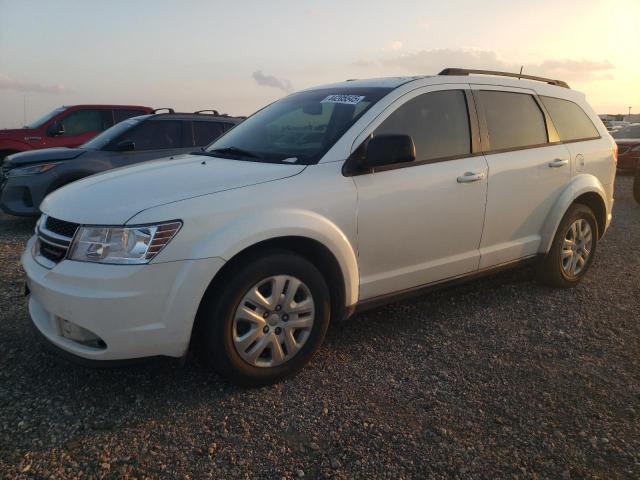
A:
[{"xmin": 193, "ymin": 209, "xmax": 359, "ymax": 305}]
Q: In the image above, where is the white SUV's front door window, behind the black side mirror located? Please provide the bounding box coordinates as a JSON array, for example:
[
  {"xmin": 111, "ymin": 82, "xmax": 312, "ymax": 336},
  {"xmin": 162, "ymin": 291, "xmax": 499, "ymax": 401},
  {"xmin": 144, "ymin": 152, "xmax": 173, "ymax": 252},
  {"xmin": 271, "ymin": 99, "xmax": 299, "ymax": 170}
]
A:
[{"xmin": 374, "ymin": 90, "xmax": 471, "ymax": 161}]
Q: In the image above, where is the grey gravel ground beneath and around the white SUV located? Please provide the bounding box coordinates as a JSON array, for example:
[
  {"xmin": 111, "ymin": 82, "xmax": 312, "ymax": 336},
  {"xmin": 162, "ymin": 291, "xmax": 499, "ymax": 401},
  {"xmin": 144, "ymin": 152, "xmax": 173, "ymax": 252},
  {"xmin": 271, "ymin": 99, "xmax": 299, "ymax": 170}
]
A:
[{"xmin": 0, "ymin": 177, "xmax": 640, "ymax": 479}]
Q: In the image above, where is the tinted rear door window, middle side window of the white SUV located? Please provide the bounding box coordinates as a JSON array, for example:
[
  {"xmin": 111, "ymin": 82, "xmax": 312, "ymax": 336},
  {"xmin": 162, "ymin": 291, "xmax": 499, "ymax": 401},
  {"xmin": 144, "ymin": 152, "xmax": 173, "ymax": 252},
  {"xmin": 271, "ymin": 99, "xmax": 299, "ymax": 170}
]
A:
[{"xmin": 476, "ymin": 90, "xmax": 548, "ymax": 150}]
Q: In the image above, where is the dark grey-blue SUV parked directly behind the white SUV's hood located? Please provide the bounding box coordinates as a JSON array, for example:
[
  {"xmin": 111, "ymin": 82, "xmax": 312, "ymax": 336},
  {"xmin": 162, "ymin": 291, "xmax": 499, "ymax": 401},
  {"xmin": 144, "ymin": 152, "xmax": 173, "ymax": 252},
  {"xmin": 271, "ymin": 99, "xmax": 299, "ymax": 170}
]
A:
[{"xmin": 0, "ymin": 109, "xmax": 244, "ymax": 216}]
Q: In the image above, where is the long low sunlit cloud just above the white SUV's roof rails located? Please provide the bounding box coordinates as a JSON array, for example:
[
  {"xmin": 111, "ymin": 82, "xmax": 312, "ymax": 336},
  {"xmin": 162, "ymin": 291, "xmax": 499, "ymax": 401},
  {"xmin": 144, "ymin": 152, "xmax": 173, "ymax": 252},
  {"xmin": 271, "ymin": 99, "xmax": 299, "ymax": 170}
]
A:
[{"xmin": 362, "ymin": 48, "xmax": 615, "ymax": 81}]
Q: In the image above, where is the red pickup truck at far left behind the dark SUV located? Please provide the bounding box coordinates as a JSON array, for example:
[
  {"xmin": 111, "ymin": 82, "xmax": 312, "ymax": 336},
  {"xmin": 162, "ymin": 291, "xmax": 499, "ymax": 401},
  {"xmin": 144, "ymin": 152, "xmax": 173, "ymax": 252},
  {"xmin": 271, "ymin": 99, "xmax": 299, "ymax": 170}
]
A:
[{"xmin": 0, "ymin": 105, "xmax": 153, "ymax": 159}]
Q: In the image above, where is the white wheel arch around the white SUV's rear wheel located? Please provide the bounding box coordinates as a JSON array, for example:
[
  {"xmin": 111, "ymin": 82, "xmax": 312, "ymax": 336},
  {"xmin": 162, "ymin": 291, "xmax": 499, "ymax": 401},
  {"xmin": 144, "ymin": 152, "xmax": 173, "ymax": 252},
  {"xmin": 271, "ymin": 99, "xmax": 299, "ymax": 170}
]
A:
[{"xmin": 540, "ymin": 175, "xmax": 609, "ymax": 253}]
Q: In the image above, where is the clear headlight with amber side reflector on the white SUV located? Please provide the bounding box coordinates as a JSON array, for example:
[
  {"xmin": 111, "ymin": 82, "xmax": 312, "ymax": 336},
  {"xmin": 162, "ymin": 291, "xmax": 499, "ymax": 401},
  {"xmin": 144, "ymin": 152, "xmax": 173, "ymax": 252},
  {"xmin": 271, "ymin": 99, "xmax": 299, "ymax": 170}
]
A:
[{"xmin": 69, "ymin": 221, "xmax": 182, "ymax": 264}]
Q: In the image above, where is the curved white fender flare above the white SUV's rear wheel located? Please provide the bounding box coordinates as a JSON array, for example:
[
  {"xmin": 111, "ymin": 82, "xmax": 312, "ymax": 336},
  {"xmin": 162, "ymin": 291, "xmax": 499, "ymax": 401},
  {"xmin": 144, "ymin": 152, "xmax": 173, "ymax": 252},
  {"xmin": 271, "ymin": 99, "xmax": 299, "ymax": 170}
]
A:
[{"xmin": 539, "ymin": 173, "xmax": 611, "ymax": 253}]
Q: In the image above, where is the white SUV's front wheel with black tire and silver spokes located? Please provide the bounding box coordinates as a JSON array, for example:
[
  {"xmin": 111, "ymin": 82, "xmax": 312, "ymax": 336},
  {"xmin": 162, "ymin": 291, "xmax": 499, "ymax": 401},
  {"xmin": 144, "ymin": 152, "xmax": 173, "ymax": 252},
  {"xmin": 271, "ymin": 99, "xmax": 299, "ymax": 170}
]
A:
[{"xmin": 198, "ymin": 251, "xmax": 330, "ymax": 386}]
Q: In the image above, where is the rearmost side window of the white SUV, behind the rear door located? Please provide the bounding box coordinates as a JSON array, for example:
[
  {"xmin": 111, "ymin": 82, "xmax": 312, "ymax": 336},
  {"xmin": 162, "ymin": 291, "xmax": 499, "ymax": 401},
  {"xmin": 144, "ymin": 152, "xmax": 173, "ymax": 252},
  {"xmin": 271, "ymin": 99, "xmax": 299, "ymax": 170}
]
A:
[{"xmin": 540, "ymin": 97, "xmax": 600, "ymax": 141}]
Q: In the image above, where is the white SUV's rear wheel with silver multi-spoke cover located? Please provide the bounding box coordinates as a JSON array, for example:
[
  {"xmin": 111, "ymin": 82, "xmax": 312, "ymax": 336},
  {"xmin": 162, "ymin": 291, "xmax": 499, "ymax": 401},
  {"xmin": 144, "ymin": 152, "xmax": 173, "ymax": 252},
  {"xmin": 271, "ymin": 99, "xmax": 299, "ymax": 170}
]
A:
[{"xmin": 538, "ymin": 203, "xmax": 598, "ymax": 288}]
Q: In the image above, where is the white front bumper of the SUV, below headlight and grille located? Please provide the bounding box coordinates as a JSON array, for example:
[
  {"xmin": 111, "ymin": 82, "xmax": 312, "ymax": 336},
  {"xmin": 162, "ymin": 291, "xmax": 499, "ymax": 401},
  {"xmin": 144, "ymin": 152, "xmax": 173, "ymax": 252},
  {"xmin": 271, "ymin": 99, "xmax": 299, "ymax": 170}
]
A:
[{"xmin": 22, "ymin": 238, "xmax": 224, "ymax": 361}]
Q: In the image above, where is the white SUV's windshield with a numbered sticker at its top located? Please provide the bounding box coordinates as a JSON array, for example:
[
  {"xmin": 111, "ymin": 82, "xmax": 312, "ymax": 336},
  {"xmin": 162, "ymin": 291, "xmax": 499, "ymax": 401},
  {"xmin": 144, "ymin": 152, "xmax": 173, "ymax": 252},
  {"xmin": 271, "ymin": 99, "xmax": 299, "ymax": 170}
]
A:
[{"xmin": 205, "ymin": 87, "xmax": 391, "ymax": 165}]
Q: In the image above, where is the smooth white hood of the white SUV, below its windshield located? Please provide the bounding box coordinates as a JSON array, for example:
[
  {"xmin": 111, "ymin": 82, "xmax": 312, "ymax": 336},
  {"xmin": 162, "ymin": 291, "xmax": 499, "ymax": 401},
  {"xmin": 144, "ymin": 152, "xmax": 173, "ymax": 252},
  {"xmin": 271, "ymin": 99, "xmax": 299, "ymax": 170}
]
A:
[{"xmin": 40, "ymin": 155, "xmax": 305, "ymax": 225}]
